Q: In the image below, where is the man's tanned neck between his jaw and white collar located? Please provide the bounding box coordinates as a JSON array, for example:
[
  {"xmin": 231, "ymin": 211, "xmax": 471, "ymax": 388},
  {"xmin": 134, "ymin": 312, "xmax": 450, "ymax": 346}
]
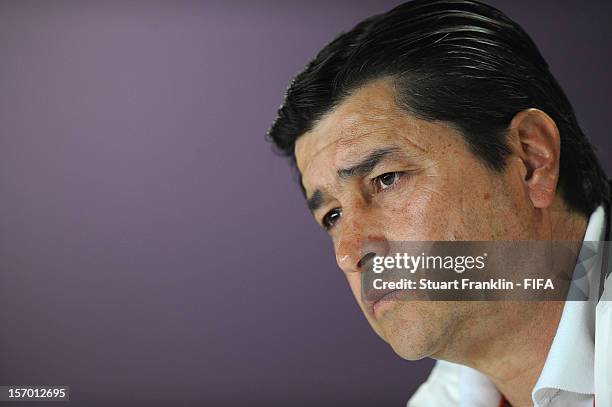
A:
[{"xmin": 444, "ymin": 207, "xmax": 587, "ymax": 407}]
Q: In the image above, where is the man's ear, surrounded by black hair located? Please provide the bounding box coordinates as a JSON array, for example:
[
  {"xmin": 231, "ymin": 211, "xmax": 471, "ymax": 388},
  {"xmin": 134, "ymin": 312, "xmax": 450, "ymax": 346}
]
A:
[{"xmin": 510, "ymin": 109, "xmax": 561, "ymax": 208}]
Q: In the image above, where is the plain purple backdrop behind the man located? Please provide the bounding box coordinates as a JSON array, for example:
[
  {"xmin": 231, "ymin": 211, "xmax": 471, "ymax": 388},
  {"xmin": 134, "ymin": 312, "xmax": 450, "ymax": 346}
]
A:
[{"xmin": 0, "ymin": 0, "xmax": 612, "ymax": 406}]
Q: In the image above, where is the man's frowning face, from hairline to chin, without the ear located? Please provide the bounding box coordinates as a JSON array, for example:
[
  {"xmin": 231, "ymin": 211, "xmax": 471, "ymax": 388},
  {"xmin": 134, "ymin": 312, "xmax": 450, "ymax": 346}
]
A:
[{"xmin": 295, "ymin": 80, "xmax": 541, "ymax": 359}]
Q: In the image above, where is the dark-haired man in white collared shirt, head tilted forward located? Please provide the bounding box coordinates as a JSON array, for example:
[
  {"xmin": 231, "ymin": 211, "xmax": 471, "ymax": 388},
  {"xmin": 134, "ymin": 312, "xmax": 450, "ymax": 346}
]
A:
[{"xmin": 269, "ymin": 0, "xmax": 612, "ymax": 407}]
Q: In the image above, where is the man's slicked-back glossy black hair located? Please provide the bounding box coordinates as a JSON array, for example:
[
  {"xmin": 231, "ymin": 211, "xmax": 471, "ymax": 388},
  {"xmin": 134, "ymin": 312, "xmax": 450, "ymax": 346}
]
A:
[{"xmin": 268, "ymin": 0, "xmax": 610, "ymax": 215}]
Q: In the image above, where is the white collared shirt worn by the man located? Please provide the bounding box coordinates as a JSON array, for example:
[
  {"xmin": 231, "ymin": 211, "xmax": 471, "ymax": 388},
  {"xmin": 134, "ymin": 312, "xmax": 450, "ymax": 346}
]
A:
[{"xmin": 407, "ymin": 207, "xmax": 612, "ymax": 407}]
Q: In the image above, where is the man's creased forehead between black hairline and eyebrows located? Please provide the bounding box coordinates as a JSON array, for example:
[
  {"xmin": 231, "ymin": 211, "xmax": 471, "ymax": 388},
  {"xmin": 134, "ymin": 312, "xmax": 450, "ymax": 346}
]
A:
[{"xmin": 295, "ymin": 79, "xmax": 428, "ymax": 194}]
